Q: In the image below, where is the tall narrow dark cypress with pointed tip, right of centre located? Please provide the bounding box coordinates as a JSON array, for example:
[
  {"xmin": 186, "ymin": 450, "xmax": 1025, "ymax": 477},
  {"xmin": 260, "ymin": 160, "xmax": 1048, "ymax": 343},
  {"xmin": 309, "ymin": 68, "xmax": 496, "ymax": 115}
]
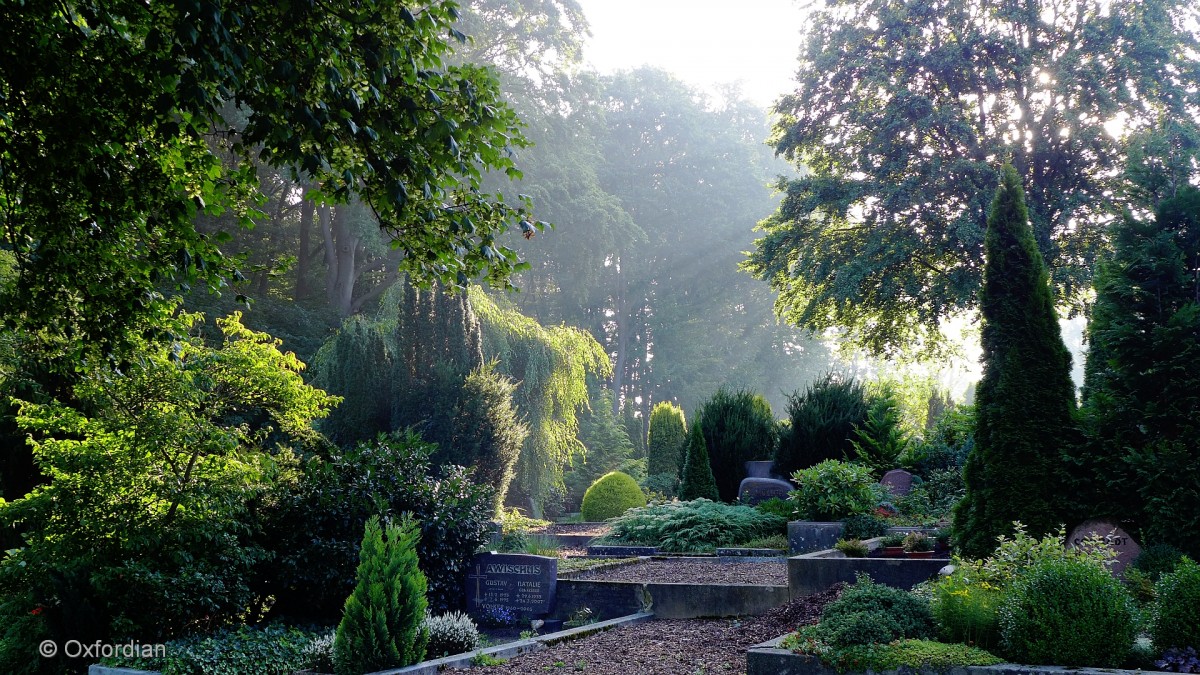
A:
[{"xmin": 954, "ymin": 166, "xmax": 1075, "ymax": 557}]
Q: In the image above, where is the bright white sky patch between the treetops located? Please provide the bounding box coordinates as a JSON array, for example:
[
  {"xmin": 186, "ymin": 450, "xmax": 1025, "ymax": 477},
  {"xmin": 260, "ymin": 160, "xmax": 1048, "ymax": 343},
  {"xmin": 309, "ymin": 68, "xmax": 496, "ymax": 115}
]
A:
[{"xmin": 578, "ymin": 0, "xmax": 804, "ymax": 107}]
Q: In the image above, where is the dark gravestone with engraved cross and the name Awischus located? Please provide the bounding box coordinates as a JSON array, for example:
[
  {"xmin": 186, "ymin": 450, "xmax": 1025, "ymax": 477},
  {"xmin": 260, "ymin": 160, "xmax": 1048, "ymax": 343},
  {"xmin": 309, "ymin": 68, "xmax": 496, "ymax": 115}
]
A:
[{"xmin": 467, "ymin": 554, "xmax": 558, "ymax": 617}]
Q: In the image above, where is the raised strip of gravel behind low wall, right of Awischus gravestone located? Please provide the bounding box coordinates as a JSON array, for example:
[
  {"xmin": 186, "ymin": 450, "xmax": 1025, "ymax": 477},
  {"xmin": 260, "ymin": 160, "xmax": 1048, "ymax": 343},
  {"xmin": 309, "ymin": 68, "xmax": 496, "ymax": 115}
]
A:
[{"xmin": 576, "ymin": 558, "xmax": 787, "ymax": 586}]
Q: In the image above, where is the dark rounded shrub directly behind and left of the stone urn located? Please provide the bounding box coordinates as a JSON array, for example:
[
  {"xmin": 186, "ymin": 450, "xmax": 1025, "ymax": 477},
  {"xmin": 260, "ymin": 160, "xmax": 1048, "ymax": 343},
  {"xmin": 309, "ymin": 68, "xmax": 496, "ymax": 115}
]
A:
[{"xmin": 695, "ymin": 387, "xmax": 778, "ymax": 502}]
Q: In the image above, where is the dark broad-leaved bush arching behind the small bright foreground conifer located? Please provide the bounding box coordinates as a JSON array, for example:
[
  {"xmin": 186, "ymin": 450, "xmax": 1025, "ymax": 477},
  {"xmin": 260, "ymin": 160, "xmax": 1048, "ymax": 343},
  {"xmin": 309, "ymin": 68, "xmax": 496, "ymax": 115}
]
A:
[{"xmin": 260, "ymin": 431, "xmax": 494, "ymax": 623}]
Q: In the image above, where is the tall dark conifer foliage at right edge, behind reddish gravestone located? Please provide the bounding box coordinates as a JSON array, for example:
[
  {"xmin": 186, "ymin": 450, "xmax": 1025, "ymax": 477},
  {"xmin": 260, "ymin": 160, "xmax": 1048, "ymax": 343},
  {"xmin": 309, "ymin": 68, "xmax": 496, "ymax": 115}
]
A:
[{"xmin": 1070, "ymin": 186, "xmax": 1200, "ymax": 556}]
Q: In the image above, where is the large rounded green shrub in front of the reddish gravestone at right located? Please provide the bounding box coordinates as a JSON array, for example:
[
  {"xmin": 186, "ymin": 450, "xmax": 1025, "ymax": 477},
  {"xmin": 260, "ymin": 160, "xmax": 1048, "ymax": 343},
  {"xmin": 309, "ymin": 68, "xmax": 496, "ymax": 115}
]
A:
[{"xmin": 998, "ymin": 558, "xmax": 1138, "ymax": 668}]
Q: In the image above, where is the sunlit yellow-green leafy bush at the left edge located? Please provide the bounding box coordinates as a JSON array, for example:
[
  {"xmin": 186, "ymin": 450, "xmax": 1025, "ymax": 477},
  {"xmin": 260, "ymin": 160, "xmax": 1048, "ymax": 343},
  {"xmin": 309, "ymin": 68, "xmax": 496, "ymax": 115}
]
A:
[{"xmin": 0, "ymin": 315, "xmax": 336, "ymax": 673}]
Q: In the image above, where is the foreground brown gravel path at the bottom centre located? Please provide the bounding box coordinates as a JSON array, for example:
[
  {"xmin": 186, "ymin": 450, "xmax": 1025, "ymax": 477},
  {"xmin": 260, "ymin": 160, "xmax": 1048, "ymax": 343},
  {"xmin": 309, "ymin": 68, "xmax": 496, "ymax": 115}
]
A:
[{"xmin": 470, "ymin": 586, "xmax": 841, "ymax": 675}]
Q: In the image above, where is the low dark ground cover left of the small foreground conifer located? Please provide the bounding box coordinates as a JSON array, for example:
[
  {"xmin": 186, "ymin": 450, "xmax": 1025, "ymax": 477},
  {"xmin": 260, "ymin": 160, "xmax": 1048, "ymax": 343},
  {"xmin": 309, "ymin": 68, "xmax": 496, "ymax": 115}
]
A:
[{"xmin": 101, "ymin": 625, "xmax": 331, "ymax": 675}]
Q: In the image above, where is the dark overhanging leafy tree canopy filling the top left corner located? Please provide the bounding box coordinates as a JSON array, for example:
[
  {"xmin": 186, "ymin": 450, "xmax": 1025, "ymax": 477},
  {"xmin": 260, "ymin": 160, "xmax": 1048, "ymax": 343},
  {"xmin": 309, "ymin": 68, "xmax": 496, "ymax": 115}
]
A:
[{"xmin": 0, "ymin": 0, "xmax": 540, "ymax": 365}]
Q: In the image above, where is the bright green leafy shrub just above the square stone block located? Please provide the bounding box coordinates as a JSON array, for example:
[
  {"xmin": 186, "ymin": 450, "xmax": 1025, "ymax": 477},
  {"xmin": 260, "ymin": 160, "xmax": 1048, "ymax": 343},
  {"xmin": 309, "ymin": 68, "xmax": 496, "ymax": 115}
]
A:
[{"xmin": 791, "ymin": 460, "xmax": 883, "ymax": 520}]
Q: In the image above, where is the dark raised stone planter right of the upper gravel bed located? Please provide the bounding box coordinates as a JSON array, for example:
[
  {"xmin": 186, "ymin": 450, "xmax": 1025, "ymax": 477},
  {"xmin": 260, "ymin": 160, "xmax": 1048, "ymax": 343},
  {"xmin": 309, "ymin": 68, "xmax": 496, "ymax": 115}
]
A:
[{"xmin": 787, "ymin": 539, "xmax": 950, "ymax": 598}]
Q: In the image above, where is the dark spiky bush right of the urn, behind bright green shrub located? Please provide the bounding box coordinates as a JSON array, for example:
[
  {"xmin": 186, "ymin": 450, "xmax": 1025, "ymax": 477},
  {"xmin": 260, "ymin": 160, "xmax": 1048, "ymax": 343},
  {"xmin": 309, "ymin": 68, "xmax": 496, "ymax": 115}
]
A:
[{"xmin": 775, "ymin": 372, "xmax": 866, "ymax": 476}]
